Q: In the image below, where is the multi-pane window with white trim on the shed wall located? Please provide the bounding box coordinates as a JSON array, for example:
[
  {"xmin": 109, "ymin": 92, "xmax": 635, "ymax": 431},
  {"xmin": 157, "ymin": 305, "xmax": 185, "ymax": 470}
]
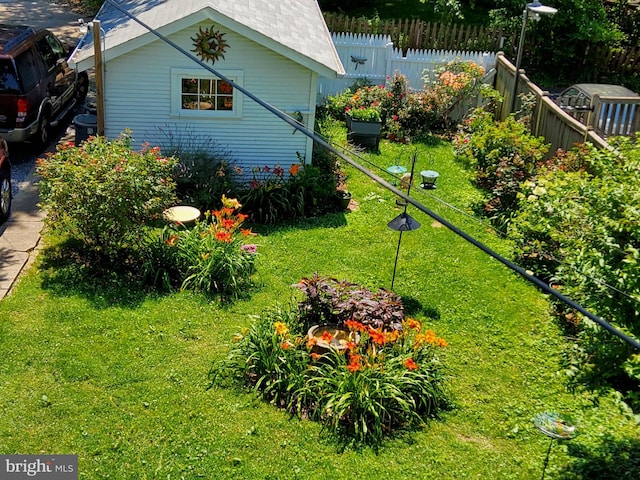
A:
[{"xmin": 171, "ymin": 69, "xmax": 243, "ymax": 118}]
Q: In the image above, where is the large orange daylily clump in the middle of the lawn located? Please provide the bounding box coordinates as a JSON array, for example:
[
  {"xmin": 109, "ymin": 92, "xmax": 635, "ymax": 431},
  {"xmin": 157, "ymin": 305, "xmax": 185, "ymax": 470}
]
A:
[{"xmin": 210, "ymin": 280, "xmax": 450, "ymax": 447}]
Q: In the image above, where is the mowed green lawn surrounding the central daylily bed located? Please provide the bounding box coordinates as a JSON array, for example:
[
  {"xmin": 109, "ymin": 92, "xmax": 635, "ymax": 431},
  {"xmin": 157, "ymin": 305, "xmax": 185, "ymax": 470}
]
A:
[{"xmin": 0, "ymin": 132, "xmax": 637, "ymax": 479}]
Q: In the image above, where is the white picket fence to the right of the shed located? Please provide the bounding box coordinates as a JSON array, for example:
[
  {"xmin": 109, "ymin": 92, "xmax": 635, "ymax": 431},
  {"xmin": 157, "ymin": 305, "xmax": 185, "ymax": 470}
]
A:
[{"xmin": 318, "ymin": 33, "xmax": 496, "ymax": 99}]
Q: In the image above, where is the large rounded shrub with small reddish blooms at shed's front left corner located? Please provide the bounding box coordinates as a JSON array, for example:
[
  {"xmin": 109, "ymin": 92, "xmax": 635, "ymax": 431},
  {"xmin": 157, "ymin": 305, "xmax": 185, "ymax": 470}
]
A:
[{"xmin": 37, "ymin": 135, "xmax": 177, "ymax": 257}]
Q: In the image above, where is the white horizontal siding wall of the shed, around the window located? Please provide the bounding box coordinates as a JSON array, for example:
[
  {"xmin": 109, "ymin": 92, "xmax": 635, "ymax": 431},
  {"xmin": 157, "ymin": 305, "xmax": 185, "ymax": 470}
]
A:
[{"xmin": 105, "ymin": 25, "xmax": 317, "ymax": 169}]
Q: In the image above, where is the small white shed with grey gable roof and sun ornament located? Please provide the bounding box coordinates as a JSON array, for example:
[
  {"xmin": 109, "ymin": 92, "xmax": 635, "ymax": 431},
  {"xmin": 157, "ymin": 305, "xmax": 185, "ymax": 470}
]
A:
[{"xmin": 71, "ymin": 0, "xmax": 344, "ymax": 171}]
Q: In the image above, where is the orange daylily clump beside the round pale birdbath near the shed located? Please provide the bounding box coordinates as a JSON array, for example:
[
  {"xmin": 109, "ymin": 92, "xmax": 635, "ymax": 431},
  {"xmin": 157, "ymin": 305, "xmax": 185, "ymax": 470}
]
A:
[{"xmin": 144, "ymin": 196, "xmax": 257, "ymax": 298}]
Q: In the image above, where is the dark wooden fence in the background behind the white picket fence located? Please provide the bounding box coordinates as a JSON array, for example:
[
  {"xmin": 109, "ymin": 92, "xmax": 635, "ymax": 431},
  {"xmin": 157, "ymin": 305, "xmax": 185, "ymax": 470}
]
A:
[{"xmin": 324, "ymin": 12, "xmax": 515, "ymax": 52}]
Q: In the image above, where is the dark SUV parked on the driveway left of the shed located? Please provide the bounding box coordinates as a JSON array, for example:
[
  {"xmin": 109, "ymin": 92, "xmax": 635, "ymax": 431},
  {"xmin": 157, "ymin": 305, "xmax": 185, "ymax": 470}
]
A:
[{"xmin": 0, "ymin": 24, "xmax": 89, "ymax": 145}]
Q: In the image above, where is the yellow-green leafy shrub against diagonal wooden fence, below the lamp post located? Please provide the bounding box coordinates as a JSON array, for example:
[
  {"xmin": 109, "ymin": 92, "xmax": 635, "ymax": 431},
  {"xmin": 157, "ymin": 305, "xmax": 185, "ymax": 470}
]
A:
[{"xmin": 453, "ymin": 109, "xmax": 549, "ymax": 226}]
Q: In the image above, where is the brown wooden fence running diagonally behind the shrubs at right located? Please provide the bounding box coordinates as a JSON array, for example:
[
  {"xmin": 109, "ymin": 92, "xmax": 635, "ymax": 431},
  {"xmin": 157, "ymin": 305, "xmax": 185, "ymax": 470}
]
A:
[{"xmin": 494, "ymin": 53, "xmax": 610, "ymax": 157}]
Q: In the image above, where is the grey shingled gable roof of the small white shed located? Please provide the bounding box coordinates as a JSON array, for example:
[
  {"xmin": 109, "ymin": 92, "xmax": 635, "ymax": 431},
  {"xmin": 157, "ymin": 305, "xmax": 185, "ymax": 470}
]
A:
[{"xmin": 70, "ymin": 0, "xmax": 344, "ymax": 76}]
